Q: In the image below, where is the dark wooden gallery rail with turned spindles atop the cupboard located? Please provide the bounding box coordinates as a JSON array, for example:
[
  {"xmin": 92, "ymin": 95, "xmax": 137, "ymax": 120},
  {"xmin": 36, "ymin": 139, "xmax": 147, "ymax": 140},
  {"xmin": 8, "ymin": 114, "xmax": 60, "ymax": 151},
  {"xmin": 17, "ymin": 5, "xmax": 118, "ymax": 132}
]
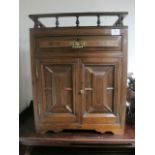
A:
[{"xmin": 29, "ymin": 12, "xmax": 128, "ymax": 28}]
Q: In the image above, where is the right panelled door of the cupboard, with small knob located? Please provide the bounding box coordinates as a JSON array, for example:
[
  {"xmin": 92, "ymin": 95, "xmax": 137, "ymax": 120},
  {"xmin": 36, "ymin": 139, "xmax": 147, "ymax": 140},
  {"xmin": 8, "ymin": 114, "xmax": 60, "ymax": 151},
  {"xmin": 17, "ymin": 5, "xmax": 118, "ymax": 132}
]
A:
[{"xmin": 80, "ymin": 58, "xmax": 122, "ymax": 124}]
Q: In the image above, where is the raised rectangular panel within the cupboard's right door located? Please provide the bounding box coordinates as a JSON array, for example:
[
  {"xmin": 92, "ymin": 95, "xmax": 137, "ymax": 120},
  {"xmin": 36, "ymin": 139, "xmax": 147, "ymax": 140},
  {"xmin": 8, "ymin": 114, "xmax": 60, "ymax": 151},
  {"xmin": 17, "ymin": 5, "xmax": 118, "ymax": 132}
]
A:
[{"xmin": 84, "ymin": 65, "xmax": 114, "ymax": 113}]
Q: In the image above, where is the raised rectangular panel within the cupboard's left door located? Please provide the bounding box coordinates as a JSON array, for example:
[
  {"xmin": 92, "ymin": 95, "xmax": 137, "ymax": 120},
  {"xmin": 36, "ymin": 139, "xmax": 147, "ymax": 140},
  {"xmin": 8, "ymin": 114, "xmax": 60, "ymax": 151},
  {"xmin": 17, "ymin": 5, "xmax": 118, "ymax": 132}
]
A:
[{"xmin": 43, "ymin": 65, "xmax": 73, "ymax": 113}]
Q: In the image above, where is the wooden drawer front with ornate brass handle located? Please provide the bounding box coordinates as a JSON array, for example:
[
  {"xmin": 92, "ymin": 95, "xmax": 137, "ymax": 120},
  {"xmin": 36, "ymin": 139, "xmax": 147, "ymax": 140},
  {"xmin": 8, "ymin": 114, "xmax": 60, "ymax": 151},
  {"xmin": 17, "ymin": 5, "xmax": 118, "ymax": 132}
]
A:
[{"xmin": 37, "ymin": 36, "xmax": 122, "ymax": 50}]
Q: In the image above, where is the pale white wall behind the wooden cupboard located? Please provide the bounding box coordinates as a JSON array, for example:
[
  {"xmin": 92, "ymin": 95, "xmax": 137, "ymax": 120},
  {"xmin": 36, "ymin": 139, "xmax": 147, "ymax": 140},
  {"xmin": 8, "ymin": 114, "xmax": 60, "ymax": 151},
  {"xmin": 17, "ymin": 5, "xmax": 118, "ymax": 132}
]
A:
[{"xmin": 19, "ymin": 0, "xmax": 135, "ymax": 112}]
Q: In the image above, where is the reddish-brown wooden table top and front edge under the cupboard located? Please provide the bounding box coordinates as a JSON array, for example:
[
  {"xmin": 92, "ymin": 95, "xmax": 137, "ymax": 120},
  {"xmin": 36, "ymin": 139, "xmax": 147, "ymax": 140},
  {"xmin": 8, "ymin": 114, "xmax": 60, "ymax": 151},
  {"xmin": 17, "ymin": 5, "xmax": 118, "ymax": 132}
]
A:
[{"xmin": 19, "ymin": 104, "xmax": 135, "ymax": 148}]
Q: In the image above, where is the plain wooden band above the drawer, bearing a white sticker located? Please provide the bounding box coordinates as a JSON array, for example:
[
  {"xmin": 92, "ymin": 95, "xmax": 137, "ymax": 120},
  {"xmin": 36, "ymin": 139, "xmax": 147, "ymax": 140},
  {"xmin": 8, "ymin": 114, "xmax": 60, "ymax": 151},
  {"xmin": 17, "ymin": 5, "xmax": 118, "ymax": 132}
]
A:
[{"xmin": 30, "ymin": 26, "xmax": 128, "ymax": 37}]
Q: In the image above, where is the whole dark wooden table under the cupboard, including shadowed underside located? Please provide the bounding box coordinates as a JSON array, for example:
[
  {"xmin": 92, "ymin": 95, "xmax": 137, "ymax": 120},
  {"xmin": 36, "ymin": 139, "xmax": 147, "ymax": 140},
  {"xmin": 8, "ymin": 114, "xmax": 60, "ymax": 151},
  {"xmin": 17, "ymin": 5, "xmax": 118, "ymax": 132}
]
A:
[{"xmin": 19, "ymin": 104, "xmax": 135, "ymax": 155}]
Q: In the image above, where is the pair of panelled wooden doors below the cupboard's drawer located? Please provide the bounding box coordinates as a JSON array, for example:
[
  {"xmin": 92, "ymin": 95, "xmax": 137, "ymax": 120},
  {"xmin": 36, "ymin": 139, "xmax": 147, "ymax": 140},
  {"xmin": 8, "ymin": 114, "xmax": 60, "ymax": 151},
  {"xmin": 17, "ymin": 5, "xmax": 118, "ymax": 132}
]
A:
[{"xmin": 36, "ymin": 58, "xmax": 122, "ymax": 125}]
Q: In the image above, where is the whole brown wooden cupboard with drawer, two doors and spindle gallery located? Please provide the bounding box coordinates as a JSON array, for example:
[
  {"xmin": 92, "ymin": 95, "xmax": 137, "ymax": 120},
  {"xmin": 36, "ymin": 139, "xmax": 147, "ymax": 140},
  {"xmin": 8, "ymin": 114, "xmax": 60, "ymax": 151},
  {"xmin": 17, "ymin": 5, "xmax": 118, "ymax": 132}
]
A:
[{"xmin": 30, "ymin": 13, "xmax": 127, "ymax": 134}]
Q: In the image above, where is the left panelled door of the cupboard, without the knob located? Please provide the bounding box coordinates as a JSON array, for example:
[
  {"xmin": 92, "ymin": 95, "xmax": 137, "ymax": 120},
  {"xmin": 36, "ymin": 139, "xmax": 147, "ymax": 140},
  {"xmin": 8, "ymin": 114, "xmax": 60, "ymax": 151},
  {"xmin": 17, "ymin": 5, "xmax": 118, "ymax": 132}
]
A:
[{"xmin": 36, "ymin": 59, "xmax": 77, "ymax": 123}]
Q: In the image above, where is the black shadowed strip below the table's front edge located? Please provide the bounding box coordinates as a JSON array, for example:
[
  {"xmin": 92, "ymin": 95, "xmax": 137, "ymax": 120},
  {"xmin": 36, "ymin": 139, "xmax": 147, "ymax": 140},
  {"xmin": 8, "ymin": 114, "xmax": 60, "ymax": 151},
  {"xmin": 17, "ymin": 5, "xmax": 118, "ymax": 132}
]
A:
[{"xmin": 20, "ymin": 147, "xmax": 135, "ymax": 155}]
